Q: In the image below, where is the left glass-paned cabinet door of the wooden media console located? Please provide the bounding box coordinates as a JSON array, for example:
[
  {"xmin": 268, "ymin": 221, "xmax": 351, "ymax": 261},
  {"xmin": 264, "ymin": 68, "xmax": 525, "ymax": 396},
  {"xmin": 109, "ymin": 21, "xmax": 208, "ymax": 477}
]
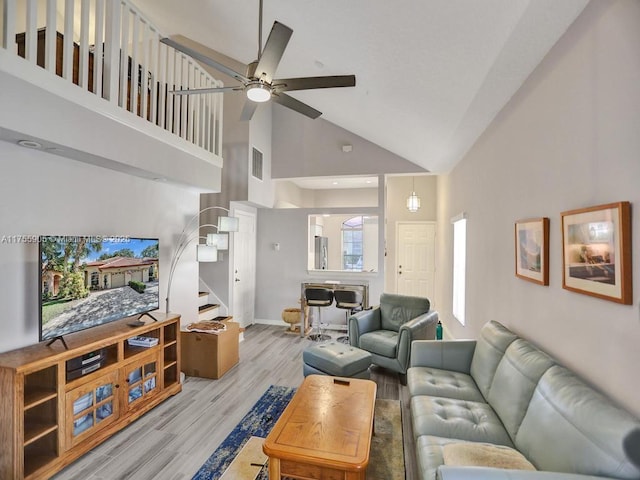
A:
[{"xmin": 66, "ymin": 372, "xmax": 119, "ymax": 448}]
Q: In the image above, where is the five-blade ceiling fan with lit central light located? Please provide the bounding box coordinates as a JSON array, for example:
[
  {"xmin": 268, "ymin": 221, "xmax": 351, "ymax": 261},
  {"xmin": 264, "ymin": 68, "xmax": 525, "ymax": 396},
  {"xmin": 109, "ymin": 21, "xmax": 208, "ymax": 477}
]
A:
[{"xmin": 161, "ymin": 0, "xmax": 356, "ymax": 120}]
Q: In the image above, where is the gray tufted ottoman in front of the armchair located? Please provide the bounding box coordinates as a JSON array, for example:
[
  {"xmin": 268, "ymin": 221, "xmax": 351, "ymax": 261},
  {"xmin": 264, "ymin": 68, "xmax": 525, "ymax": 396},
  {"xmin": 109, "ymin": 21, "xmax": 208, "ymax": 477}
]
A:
[{"xmin": 302, "ymin": 342, "xmax": 371, "ymax": 378}]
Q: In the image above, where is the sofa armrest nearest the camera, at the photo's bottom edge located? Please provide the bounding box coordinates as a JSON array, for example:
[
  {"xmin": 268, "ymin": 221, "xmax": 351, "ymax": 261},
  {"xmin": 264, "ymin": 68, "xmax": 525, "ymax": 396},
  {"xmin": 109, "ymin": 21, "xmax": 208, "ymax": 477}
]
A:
[{"xmin": 436, "ymin": 465, "xmax": 613, "ymax": 480}]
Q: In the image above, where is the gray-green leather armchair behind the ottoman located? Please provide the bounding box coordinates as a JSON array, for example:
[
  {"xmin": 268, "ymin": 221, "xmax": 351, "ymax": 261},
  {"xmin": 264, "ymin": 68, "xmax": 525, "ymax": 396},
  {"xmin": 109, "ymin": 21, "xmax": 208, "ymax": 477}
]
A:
[{"xmin": 349, "ymin": 293, "xmax": 438, "ymax": 384}]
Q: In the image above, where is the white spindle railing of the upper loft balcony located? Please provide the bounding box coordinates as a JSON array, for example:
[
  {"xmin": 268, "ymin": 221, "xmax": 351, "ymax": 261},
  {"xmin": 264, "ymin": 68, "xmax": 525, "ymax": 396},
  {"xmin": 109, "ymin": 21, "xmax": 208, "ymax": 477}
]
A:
[{"xmin": 0, "ymin": 0, "xmax": 223, "ymax": 155}]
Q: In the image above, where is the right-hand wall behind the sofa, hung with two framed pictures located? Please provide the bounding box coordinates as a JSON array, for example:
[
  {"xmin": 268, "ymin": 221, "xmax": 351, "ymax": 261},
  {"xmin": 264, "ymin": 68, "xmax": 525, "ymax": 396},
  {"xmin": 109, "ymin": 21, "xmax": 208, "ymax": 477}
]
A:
[{"xmin": 436, "ymin": 0, "xmax": 640, "ymax": 415}]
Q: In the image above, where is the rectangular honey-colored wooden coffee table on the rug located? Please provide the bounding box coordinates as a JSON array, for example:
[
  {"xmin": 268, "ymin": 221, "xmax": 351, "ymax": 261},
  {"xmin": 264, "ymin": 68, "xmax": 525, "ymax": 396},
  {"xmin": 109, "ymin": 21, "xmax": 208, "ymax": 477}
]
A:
[{"xmin": 262, "ymin": 375, "xmax": 376, "ymax": 480}]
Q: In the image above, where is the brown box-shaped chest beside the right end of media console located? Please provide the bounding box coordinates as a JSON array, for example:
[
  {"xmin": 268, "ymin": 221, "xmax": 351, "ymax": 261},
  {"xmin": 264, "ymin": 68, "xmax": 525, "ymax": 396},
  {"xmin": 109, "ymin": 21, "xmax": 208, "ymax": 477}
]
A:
[{"xmin": 180, "ymin": 320, "xmax": 240, "ymax": 379}]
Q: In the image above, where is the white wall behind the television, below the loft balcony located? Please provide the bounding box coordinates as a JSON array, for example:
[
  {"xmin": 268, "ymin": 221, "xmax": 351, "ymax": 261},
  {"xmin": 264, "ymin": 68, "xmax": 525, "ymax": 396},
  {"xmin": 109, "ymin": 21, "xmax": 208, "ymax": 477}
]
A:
[{"xmin": 0, "ymin": 142, "xmax": 199, "ymax": 352}]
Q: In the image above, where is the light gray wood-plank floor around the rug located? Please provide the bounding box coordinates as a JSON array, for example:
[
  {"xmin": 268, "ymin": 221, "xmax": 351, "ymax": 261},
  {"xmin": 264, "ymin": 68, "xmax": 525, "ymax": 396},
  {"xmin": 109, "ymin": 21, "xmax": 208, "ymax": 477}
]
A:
[{"xmin": 53, "ymin": 325, "xmax": 417, "ymax": 480}]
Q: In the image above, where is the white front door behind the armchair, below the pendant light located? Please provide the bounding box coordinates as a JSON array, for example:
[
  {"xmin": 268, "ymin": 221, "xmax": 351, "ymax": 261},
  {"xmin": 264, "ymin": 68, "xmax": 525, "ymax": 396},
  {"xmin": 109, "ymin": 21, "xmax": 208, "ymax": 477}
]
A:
[{"xmin": 396, "ymin": 222, "xmax": 436, "ymax": 302}]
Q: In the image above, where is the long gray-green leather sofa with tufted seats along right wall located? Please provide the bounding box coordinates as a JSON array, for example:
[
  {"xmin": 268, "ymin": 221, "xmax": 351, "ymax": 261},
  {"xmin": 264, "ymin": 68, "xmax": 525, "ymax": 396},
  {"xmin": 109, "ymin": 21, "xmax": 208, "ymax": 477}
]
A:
[{"xmin": 407, "ymin": 322, "xmax": 640, "ymax": 480}]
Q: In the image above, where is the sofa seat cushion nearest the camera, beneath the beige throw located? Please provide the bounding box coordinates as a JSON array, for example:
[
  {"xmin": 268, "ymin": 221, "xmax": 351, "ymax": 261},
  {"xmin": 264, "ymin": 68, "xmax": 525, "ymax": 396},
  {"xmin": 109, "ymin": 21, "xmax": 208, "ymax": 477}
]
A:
[{"xmin": 416, "ymin": 435, "xmax": 535, "ymax": 480}]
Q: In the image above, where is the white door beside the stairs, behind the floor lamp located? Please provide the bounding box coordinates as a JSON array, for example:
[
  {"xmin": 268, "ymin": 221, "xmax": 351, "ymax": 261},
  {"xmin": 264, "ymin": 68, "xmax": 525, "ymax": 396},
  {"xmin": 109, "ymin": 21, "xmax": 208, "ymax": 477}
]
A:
[{"xmin": 231, "ymin": 209, "xmax": 256, "ymax": 328}]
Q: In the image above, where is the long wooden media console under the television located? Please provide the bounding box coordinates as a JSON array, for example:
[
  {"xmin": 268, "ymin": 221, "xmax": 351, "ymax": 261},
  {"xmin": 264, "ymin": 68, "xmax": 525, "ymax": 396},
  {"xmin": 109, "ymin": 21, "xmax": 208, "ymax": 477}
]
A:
[{"xmin": 0, "ymin": 312, "xmax": 182, "ymax": 480}]
